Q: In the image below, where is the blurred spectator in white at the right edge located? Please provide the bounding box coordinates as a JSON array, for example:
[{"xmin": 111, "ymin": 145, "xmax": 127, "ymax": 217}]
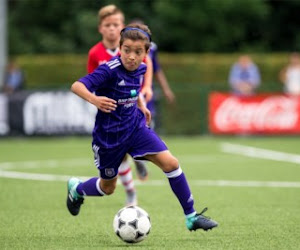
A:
[{"xmin": 279, "ymin": 53, "xmax": 300, "ymax": 95}]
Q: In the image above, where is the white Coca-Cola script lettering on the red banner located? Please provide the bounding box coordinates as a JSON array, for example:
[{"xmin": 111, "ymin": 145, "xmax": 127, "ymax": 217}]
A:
[{"xmin": 214, "ymin": 96, "xmax": 300, "ymax": 132}]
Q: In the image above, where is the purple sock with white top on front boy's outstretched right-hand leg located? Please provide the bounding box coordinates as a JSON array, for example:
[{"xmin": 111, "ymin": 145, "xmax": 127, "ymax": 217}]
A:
[{"xmin": 165, "ymin": 166, "xmax": 196, "ymax": 215}]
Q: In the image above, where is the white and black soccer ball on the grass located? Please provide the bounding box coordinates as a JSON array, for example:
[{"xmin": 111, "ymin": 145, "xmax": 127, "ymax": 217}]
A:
[{"xmin": 113, "ymin": 206, "xmax": 151, "ymax": 243}]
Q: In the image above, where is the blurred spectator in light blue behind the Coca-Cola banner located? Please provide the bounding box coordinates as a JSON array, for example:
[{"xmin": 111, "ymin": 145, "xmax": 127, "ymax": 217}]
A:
[{"xmin": 229, "ymin": 55, "xmax": 260, "ymax": 96}]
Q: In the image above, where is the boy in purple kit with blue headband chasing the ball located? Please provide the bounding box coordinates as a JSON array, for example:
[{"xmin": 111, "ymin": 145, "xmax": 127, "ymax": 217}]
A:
[{"xmin": 67, "ymin": 24, "xmax": 218, "ymax": 230}]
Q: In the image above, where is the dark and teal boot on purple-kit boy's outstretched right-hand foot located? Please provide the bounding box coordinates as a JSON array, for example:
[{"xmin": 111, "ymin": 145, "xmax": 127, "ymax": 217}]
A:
[{"xmin": 185, "ymin": 207, "xmax": 218, "ymax": 231}]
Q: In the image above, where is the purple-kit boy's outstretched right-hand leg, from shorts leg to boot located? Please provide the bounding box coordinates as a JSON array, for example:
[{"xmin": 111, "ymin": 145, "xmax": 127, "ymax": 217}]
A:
[{"xmin": 129, "ymin": 127, "xmax": 218, "ymax": 230}]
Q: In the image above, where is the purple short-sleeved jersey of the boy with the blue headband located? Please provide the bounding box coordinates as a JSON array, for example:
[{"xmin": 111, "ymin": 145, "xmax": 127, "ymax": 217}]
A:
[{"xmin": 78, "ymin": 56, "xmax": 147, "ymax": 148}]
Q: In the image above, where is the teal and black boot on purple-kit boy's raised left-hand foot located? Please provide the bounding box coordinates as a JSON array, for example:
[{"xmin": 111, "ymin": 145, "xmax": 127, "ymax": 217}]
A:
[{"xmin": 67, "ymin": 177, "xmax": 84, "ymax": 216}]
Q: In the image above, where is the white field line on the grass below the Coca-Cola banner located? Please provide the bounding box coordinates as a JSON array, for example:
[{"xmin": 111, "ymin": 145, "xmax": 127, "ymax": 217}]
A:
[{"xmin": 221, "ymin": 142, "xmax": 300, "ymax": 164}]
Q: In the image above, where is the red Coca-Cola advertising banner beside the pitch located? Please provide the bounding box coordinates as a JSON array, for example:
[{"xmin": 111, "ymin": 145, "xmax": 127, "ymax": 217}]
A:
[{"xmin": 209, "ymin": 92, "xmax": 300, "ymax": 134}]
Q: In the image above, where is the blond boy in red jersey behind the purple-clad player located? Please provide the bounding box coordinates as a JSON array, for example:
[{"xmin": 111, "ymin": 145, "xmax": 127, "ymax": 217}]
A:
[{"xmin": 87, "ymin": 5, "xmax": 152, "ymax": 206}]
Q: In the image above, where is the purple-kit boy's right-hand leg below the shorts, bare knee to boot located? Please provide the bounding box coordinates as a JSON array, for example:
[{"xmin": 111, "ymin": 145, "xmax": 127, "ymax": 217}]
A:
[{"xmin": 145, "ymin": 151, "xmax": 218, "ymax": 230}]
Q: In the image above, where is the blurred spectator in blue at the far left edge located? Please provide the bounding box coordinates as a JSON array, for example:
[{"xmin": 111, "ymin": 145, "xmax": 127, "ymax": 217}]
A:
[{"xmin": 3, "ymin": 61, "xmax": 25, "ymax": 94}]
